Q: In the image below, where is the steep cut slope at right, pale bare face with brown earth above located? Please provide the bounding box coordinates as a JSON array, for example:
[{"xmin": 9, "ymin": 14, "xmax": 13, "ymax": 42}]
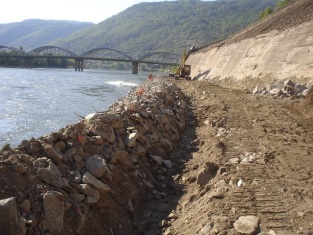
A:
[{"xmin": 187, "ymin": 0, "xmax": 313, "ymax": 88}]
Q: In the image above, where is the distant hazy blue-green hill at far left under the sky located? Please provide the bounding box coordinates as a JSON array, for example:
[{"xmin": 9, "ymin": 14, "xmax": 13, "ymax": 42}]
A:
[{"xmin": 0, "ymin": 19, "xmax": 93, "ymax": 51}]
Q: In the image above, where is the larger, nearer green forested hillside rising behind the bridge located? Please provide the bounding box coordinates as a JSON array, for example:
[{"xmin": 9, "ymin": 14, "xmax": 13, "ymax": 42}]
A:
[{"xmin": 53, "ymin": 0, "xmax": 277, "ymax": 55}]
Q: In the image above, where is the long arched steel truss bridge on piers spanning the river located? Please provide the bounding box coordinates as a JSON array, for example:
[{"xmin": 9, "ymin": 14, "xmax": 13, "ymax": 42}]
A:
[{"xmin": 0, "ymin": 46, "xmax": 180, "ymax": 74}]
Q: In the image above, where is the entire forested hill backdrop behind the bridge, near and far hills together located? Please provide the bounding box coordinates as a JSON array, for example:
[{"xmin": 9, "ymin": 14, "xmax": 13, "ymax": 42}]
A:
[{"xmin": 0, "ymin": 0, "xmax": 277, "ymax": 57}]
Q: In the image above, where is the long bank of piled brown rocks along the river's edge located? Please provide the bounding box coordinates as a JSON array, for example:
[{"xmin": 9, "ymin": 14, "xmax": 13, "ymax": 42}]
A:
[{"xmin": 0, "ymin": 77, "xmax": 188, "ymax": 235}]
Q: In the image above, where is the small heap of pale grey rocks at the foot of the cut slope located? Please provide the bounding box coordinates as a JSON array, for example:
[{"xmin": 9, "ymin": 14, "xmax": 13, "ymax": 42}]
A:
[{"xmin": 252, "ymin": 80, "xmax": 313, "ymax": 98}]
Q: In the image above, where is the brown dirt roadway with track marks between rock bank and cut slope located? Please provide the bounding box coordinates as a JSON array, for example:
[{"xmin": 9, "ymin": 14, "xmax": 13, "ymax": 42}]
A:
[{"xmin": 134, "ymin": 80, "xmax": 313, "ymax": 235}]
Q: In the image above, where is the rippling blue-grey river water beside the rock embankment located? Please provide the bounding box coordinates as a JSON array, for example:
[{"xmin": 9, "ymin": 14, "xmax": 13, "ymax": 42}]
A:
[{"xmin": 0, "ymin": 68, "xmax": 148, "ymax": 147}]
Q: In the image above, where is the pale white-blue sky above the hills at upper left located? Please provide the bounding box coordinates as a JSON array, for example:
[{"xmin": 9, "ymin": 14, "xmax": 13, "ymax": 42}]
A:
[{"xmin": 0, "ymin": 0, "xmax": 176, "ymax": 24}]
